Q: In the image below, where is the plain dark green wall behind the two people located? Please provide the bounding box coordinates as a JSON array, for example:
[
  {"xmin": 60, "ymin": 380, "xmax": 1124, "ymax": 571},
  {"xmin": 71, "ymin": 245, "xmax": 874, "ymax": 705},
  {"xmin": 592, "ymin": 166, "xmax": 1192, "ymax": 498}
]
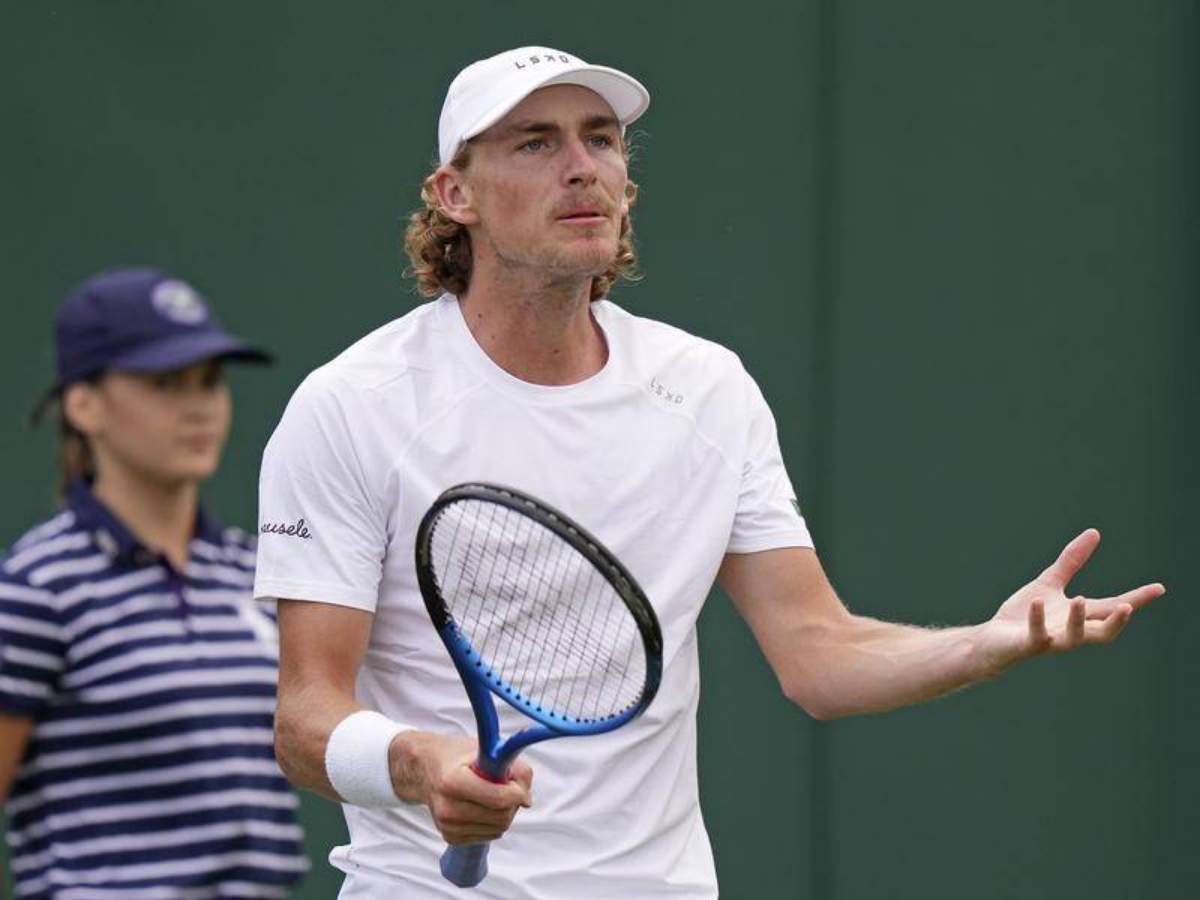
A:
[{"xmin": 0, "ymin": 0, "xmax": 1200, "ymax": 900}]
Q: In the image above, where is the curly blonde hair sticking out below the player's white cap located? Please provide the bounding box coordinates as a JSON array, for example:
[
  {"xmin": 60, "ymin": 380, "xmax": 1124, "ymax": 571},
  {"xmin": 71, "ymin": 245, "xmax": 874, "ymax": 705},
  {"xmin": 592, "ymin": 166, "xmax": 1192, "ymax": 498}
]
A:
[{"xmin": 404, "ymin": 144, "xmax": 641, "ymax": 300}]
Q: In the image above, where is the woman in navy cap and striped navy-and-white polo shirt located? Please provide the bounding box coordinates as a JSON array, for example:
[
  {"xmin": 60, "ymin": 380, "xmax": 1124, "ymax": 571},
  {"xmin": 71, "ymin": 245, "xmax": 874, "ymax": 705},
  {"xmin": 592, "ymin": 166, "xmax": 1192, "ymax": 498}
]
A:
[{"xmin": 0, "ymin": 269, "xmax": 307, "ymax": 900}]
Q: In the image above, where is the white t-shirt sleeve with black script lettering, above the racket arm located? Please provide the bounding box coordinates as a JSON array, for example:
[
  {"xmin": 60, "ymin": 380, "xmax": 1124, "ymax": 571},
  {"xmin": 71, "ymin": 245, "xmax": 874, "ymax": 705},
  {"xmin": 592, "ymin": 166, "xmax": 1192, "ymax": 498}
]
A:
[{"xmin": 254, "ymin": 370, "xmax": 388, "ymax": 612}]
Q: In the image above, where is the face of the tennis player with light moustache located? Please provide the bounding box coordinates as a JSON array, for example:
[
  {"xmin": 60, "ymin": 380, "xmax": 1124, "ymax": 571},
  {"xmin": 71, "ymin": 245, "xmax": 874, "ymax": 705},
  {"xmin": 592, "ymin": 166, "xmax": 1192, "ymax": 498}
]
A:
[{"xmin": 456, "ymin": 84, "xmax": 629, "ymax": 277}]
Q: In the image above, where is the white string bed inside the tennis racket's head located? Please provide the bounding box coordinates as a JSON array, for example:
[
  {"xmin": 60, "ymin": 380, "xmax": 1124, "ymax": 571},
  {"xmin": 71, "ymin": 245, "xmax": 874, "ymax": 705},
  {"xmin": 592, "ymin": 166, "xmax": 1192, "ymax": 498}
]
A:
[{"xmin": 431, "ymin": 499, "xmax": 647, "ymax": 720}]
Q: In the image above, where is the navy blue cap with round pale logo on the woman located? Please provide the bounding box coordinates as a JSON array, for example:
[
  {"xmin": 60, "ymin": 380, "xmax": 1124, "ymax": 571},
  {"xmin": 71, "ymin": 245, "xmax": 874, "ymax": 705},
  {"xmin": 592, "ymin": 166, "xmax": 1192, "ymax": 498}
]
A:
[{"xmin": 35, "ymin": 269, "xmax": 271, "ymax": 418}]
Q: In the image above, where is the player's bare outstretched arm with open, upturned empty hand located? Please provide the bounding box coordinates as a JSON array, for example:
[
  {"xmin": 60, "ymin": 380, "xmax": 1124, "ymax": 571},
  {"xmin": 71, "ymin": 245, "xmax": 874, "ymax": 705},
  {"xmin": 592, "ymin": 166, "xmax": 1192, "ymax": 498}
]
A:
[{"xmin": 718, "ymin": 529, "xmax": 1164, "ymax": 719}]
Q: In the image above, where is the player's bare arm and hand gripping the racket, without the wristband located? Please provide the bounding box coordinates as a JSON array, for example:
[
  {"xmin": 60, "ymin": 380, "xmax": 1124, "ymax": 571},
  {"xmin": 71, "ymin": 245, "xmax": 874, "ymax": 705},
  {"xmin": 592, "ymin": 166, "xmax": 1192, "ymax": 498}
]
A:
[{"xmin": 275, "ymin": 600, "xmax": 533, "ymax": 844}]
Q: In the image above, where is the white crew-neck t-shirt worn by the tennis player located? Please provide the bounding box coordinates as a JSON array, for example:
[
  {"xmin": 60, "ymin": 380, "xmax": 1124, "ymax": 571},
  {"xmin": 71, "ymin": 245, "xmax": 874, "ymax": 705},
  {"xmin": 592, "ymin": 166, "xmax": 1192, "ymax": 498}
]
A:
[{"xmin": 254, "ymin": 295, "xmax": 811, "ymax": 900}]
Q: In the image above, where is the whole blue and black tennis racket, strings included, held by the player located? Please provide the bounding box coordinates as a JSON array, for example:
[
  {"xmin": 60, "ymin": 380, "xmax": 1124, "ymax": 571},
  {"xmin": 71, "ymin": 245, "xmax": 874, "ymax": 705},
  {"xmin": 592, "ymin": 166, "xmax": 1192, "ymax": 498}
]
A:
[{"xmin": 416, "ymin": 484, "xmax": 662, "ymax": 887}]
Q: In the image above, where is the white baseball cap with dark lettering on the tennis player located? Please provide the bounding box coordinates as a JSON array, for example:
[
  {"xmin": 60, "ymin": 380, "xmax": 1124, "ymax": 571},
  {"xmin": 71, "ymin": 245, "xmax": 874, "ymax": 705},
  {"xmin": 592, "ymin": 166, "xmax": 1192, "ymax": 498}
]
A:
[{"xmin": 438, "ymin": 47, "xmax": 650, "ymax": 166}]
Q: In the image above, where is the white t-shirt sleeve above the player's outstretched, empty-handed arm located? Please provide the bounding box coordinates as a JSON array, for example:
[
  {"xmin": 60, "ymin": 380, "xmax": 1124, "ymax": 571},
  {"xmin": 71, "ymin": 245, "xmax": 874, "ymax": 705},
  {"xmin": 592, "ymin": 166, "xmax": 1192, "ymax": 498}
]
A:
[{"xmin": 726, "ymin": 370, "xmax": 812, "ymax": 553}]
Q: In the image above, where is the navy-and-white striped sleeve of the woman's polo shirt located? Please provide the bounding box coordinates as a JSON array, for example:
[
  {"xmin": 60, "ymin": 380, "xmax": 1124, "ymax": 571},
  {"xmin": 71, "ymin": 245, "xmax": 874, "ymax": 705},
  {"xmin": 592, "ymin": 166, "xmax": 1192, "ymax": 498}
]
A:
[{"xmin": 0, "ymin": 569, "xmax": 66, "ymax": 719}]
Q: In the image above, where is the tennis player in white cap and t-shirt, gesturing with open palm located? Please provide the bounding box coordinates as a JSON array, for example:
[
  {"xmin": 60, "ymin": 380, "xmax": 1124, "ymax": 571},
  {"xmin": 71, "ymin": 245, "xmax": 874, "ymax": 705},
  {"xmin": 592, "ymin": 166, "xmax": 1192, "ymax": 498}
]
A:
[{"xmin": 256, "ymin": 47, "xmax": 1163, "ymax": 900}]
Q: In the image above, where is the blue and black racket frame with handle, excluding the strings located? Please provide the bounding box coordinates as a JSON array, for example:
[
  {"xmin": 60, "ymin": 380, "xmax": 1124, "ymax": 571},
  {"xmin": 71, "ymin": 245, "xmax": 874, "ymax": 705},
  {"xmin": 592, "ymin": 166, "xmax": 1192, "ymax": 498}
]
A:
[{"xmin": 416, "ymin": 482, "xmax": 662, "ymax": 887}]
